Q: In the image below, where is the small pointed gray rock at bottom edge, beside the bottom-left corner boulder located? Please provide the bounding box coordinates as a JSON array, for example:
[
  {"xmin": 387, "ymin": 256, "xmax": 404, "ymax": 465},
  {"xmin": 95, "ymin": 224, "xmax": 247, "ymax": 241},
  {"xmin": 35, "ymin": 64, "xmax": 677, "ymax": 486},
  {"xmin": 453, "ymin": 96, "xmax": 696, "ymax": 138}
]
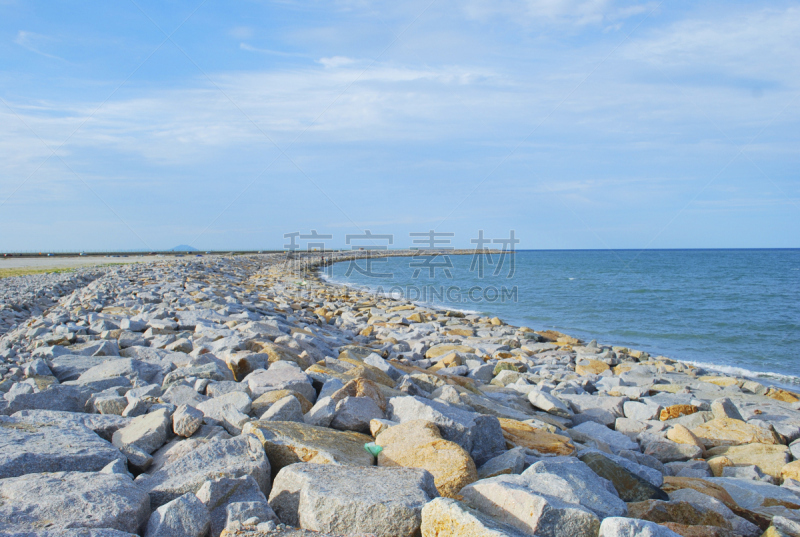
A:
[{"xmin": 144, "ymin": 492, "xmax": 211, "ymax": 537}]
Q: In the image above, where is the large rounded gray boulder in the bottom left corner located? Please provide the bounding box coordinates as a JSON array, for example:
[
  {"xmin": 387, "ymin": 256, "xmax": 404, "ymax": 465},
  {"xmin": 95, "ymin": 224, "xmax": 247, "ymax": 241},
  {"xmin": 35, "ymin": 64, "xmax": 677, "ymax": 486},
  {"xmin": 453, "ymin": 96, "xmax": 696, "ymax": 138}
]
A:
[{"xmin": 0, "ymin": 472, "xmax": 150, "ymax": 535}]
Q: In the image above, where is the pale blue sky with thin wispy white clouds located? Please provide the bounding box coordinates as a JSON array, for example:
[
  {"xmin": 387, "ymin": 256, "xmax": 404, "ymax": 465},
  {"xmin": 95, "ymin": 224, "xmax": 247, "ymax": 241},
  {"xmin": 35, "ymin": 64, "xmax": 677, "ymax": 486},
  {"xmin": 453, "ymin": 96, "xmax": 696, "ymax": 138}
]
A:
[{"xmin": 0, "ymin": 0, "xmax": 800, "ymax": 251}]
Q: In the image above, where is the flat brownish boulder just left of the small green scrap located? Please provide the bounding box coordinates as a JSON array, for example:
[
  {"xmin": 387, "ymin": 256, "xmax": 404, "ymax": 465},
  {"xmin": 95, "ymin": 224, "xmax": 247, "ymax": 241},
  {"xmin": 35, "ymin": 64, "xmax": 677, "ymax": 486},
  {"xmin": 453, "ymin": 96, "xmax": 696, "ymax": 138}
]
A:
[{"xmin": 243, "ymin": 421, "xmax": 374, "ymax": 473}]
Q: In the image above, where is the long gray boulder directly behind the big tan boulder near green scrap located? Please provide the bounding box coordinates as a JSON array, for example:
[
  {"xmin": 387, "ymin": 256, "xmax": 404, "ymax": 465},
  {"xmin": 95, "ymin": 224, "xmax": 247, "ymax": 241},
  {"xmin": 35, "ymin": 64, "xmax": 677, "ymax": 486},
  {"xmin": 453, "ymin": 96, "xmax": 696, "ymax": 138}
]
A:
[{"xmin": 386, "ymin": 396, "xmax": 506, "ymax": 466}]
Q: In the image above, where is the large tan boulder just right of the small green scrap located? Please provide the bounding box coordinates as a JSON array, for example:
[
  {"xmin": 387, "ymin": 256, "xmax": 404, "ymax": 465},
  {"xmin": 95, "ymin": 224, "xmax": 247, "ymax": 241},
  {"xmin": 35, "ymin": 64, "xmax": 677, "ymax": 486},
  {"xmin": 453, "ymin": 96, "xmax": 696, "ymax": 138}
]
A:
[{"xmin": 375, "ymin": 420, "xmax": 478, "ymax": 498}]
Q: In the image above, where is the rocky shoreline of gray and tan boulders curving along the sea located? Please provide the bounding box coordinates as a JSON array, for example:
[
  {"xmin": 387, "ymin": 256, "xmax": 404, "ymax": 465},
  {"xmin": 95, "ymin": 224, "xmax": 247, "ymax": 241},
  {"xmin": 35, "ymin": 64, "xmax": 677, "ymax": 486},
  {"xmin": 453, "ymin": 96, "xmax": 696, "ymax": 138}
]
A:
[{"xmin": 0, "ymin": 252, "xmax": 800, "ymax": 537}]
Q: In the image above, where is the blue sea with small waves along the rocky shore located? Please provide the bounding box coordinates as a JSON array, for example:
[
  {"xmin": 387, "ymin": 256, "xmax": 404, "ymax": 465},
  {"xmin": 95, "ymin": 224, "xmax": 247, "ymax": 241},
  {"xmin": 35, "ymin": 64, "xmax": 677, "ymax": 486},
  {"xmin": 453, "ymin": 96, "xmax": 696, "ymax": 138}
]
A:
[{"xmin": 326, "ymin": 249, "xmax": 800, "ymax": 387}]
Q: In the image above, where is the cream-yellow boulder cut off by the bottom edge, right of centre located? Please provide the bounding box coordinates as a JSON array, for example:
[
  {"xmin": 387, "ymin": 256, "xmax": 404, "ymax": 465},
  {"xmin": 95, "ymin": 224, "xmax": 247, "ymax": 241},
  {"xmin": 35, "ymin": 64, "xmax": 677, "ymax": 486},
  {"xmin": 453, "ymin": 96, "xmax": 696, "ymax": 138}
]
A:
[{"xmin": 422, "ymin": 498, "xmax": 527, "ymax": 537}]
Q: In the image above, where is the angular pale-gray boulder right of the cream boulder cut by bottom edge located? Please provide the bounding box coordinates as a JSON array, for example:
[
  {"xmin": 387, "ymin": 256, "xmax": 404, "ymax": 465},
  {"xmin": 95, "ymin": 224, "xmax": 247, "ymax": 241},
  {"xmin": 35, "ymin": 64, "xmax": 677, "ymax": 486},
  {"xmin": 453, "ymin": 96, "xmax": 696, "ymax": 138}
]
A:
[{"xmin": 460, "ymin": 475, "xmax": 600, "ymax": 537}]
